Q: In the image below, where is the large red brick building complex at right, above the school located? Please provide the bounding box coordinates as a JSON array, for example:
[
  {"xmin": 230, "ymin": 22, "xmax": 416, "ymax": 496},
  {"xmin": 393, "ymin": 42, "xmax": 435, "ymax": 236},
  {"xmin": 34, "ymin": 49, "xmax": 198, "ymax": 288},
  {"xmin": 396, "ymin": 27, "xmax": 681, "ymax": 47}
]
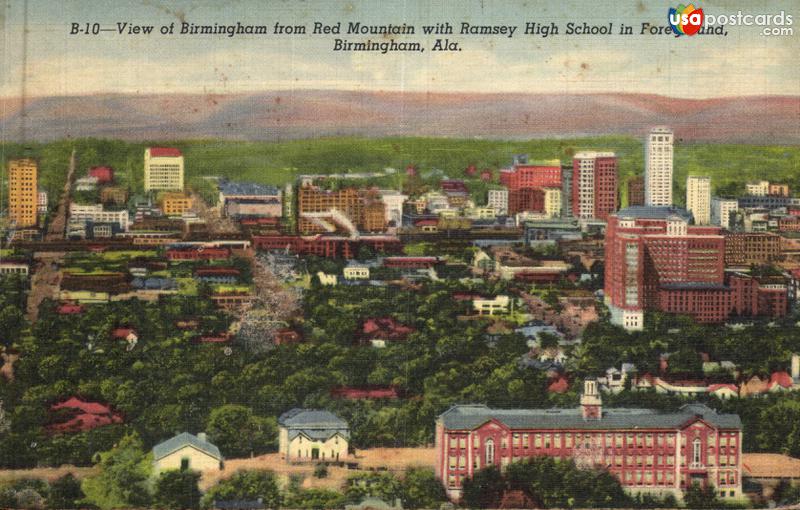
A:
[{"xmin": 605, "ymin": 207, "xmax": 789, "ymax": 330}]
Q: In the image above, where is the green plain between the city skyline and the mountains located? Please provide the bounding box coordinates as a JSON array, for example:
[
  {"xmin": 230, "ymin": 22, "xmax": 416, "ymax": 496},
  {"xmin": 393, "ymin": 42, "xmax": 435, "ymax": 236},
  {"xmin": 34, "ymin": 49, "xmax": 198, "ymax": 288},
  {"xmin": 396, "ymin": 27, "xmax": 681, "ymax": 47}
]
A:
[{"xmin": 0, "ymin": 136, "xmax": 800, "ymax": 207}]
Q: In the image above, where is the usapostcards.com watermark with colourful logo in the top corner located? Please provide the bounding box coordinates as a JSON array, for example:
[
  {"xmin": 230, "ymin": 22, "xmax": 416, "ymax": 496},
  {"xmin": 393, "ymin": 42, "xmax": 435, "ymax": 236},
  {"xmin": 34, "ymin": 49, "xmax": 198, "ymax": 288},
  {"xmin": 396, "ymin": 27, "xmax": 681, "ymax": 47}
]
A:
[{"xmin": 668, "ymin": 4, "xmax": 794, "ymax": 37}]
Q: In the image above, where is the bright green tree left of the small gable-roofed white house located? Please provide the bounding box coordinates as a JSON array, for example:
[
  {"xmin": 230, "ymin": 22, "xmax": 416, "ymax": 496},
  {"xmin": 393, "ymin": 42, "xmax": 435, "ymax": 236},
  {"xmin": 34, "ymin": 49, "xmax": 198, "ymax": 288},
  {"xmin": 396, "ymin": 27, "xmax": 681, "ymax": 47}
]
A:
[{"xmin": 82, "ymin": 433, "xmax": 152, "ymax": 509}]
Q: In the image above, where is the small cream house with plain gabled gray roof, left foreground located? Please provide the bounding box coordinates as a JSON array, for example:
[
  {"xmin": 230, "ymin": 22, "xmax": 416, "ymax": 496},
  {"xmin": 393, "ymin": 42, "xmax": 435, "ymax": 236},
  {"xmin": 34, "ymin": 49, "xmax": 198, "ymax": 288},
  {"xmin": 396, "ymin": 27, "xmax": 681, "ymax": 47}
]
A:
[{"xmin": 153, "ymin": 432, "xmax": 224, "ymax": 472}]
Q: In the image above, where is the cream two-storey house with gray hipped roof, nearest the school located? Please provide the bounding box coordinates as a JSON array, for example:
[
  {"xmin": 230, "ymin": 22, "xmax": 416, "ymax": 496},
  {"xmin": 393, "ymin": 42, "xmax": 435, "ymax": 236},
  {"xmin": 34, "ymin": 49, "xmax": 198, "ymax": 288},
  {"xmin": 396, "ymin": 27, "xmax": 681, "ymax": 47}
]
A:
[{"xmin": 278, "ymin": 408, "xmax": 350, "ymax": 462}]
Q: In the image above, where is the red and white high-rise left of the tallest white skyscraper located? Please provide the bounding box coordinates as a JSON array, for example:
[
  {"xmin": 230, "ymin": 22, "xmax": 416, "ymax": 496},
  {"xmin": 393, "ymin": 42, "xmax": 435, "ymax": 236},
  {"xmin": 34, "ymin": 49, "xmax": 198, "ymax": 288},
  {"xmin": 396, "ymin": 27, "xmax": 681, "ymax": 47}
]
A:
[{"xmin": 571, "ymin": 151, "xmax": 619, "ymax": 221}]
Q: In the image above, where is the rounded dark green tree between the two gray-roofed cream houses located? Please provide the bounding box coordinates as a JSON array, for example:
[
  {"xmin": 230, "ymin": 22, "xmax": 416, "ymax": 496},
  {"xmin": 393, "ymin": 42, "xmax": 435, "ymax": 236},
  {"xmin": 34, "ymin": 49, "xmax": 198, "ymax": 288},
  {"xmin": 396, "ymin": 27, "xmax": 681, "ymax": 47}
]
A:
[{"xmin": 206, "ymin": 404, "xmax": 278, "ymax": 457}]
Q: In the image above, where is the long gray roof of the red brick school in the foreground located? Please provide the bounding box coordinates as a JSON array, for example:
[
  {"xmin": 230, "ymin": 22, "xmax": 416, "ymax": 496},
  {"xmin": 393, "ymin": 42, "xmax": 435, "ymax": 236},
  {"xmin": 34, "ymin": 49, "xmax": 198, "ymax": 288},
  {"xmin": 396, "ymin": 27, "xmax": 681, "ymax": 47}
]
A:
[{"xmin": 439, "ymin": 404, "xmax": 742, "ymax": 430}]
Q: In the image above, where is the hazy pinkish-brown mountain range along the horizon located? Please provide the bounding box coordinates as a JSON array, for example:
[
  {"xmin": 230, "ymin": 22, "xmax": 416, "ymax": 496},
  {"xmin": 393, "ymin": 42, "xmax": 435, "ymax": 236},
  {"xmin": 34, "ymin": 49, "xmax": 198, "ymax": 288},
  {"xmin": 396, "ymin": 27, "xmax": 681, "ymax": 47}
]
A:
[{"xmin": 0, "ymin": 90, "xmax": 800, "ymax": 144}]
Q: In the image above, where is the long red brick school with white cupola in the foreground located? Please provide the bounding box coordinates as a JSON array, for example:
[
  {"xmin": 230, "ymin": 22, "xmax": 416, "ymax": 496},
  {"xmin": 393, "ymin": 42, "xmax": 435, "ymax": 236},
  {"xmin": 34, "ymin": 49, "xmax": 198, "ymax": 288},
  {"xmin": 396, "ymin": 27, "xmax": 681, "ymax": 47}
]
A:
[{"xmin": 435, "ymin": 379, "xmax": 742, "ymax": 500}]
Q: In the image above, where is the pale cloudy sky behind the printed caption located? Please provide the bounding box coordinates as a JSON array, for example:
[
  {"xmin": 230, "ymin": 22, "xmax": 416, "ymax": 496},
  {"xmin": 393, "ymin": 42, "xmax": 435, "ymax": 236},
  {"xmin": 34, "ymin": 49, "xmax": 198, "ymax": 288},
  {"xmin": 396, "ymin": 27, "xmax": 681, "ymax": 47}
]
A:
[{"xmin": 0, "ymin": 0, "xmax": 800, "ymax": 98}]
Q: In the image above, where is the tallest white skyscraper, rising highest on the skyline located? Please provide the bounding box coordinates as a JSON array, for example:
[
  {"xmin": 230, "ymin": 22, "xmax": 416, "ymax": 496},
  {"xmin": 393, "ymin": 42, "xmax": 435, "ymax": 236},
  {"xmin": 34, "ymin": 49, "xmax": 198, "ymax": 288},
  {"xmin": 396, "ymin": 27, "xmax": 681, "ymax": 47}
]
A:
[{"xmin": 644, "ymin": 126, "xmax": 673, "ymax": 206}]
